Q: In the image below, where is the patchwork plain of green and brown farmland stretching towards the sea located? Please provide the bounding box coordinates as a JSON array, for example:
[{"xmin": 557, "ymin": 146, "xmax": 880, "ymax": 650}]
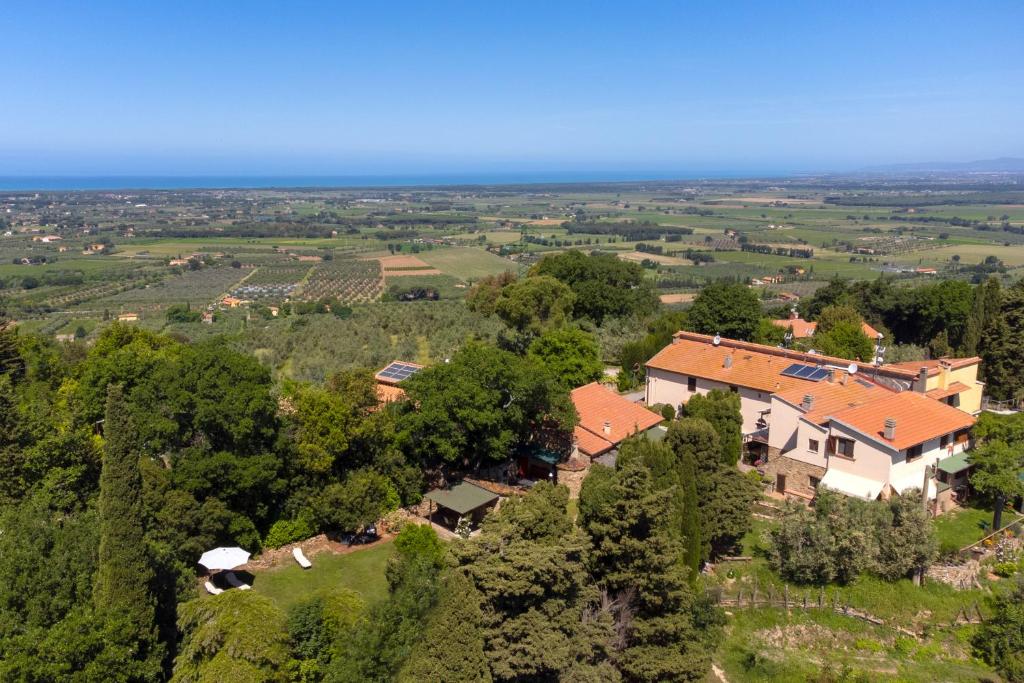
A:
[{"xmin": 0, "ymin": 177, "xmax": 1024, "ymax": 348}]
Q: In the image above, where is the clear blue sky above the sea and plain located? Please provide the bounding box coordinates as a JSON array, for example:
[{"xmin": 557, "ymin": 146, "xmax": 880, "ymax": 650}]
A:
[{"xmin": 0, "ymin": 0, "xmax": 1024, "ymax": 175}]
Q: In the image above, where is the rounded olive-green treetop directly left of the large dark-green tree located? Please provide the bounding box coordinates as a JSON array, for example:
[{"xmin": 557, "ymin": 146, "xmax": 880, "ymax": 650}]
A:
[{"xmin": 495, "ymin": 275, "xmax": 575, "ymax": 337}]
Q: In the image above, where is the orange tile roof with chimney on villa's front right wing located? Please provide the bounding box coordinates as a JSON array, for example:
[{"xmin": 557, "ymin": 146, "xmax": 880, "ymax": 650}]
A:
[{"xmin": 829, "ymin": 391, "xmax": 975, "ymax": 451}]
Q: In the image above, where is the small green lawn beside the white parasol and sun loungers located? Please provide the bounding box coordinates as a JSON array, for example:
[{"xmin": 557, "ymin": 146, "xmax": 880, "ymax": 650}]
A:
[{"xmin": 253, "ymin": 541, "xmax": 394, "ymax": 609}]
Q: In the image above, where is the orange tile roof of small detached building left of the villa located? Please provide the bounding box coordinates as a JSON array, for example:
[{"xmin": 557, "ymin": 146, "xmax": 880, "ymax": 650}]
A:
[{"xmin": 569, "ymin": 382, "xmax": 663, "ymax": 455}]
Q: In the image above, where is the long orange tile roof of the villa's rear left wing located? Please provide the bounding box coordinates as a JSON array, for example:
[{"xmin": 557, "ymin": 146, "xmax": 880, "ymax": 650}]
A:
[{"xmin": 647, "ymin": 332, "xmax": 850, "ymax": 393}]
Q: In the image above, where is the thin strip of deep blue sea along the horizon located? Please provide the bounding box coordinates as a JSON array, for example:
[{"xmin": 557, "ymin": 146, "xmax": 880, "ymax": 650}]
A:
[{"xmin": 0, "ymin": 171, "xmax": 788, "ymax": 191}]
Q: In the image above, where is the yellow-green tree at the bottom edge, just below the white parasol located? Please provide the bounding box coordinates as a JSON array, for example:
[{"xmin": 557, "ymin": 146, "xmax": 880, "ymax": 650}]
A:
[{"xmin": 171, "ymin": 591, "xmax": 290, "ymax": 683}]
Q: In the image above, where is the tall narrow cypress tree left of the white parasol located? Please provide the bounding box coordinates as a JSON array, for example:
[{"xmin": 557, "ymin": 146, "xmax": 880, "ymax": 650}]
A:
[{"xmin": 92, "ymin": 385, "xmax": 163, "ymax": 678}]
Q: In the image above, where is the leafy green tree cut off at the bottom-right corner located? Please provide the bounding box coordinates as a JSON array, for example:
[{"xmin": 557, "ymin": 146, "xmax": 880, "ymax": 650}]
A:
[{"xmin": 973, "ymin": 574, "xmax": 1024, "ymax": 683}]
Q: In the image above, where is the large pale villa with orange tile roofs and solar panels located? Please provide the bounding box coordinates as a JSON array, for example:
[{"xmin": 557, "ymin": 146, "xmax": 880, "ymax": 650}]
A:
[{"xmin": 646, "ymin": 332, "xmax": 984, "ymax": 509}]
